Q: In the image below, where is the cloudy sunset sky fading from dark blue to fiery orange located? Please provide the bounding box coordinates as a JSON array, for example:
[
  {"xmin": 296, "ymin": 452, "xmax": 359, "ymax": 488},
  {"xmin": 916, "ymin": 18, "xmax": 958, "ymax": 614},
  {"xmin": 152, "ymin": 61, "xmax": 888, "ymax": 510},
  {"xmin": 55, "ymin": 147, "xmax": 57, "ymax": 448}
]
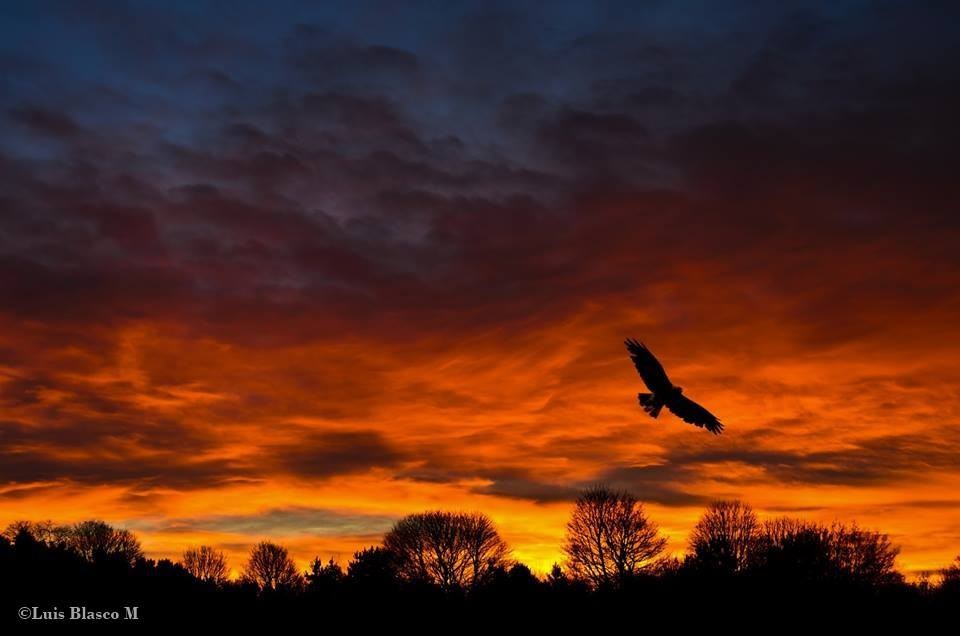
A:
[{"xmin": 0, "ymin": 0, "xmax": 960, "ymax": 573}]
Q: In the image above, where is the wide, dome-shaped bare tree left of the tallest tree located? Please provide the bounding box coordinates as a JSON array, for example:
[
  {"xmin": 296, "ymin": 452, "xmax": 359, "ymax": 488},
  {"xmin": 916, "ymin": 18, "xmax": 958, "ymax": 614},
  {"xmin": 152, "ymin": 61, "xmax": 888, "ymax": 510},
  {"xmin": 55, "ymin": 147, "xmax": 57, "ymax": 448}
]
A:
[{"xmin": 383, "ymin": 511, "xmax": 509, "ymax": 590}]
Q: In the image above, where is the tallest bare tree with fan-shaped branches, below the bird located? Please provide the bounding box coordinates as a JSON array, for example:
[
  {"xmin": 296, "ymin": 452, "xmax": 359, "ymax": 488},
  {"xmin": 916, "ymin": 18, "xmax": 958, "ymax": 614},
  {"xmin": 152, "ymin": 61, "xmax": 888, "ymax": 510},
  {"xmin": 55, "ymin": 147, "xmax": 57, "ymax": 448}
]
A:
[{"xmin": 563, "ymin": 486, "xmax": 667, "ymax": 586}]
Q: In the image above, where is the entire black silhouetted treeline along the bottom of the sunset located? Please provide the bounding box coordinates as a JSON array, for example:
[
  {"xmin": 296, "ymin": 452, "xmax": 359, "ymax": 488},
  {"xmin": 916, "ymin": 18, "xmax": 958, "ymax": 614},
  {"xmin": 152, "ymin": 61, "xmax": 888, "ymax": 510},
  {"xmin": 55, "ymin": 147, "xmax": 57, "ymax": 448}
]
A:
[{"xmin": 0, "ymin": 487, "xmax": 960, "ymax": 624}]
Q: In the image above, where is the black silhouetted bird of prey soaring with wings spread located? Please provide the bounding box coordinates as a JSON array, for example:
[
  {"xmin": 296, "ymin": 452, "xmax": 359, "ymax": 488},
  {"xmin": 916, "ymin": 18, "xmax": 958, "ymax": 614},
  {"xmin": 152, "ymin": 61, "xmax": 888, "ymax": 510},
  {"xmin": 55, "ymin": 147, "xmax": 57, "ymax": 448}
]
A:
[{"xmin": 624, "ymin": 338, "xmax": 723, "ymax": 435}]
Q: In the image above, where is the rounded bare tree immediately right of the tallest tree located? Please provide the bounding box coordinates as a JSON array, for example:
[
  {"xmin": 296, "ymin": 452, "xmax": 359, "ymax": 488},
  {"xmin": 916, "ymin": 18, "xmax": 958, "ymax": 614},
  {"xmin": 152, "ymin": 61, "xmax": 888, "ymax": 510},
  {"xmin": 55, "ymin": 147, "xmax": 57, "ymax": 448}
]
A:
[{"xmin": 690, "ymin": 501, "xmax": 758, "ymax": 574}]
